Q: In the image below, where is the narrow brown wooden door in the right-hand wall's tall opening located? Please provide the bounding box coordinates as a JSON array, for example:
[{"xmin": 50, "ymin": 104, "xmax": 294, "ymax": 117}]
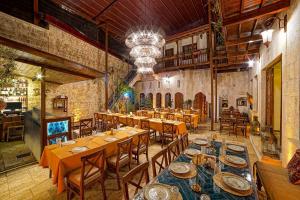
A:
[{"xmin": 266, "ymin": 67, "xmax": 274, "ymax": 127}]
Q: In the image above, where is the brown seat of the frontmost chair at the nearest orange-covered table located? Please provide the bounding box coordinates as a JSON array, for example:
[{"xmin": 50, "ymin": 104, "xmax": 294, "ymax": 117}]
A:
[{"xmin": 68, "ymin": 165, "xmax": 101, "ymax": 186}]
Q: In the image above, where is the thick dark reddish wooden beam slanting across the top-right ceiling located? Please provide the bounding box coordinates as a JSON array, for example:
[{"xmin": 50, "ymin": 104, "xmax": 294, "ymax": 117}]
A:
[{"xmin": 223, "ymin": 0, "xmax": 290, "ymax": 26}]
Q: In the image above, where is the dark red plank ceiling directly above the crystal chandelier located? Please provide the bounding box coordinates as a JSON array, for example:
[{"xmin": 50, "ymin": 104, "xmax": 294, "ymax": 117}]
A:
[{"xmin": 52, "ymin": 0, "xmax": 208, "ymax": 42}]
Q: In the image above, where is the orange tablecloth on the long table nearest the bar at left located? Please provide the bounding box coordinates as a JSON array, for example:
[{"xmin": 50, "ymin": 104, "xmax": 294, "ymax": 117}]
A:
[{"xmin": 40, "ymin": 127, "xmax": 145, "ymax": 193}]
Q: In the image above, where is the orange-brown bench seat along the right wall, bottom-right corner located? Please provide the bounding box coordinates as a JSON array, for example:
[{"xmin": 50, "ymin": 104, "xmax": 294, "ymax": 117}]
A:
[{"xmin": 254, "ymin": 161, "xmax": 300, "ymax": 200}]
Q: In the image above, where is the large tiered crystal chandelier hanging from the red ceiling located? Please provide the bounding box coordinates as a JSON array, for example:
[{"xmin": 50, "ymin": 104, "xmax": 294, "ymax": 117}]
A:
[{"xmin": 125, "ymin": 26, "xmax": 165, "ymax": 73}]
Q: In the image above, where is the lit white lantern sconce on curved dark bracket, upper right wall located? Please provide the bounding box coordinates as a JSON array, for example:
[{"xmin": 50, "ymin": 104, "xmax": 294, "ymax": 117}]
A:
[{"xmin": 261, "ymin": 15, "xmax": 287, "ymax": 47}]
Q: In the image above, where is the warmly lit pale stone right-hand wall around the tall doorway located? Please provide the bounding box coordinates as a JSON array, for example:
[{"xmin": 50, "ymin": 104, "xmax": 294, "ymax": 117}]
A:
[{"xmin": 252, "ymin": 0, "xmax": 300, "ymax": 166}]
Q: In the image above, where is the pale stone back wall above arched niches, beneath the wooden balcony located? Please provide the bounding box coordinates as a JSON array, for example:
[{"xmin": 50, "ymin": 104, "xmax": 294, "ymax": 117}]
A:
[{"xmin": 134, "ymin": 69, "xmax": 250, "ymax": 117}]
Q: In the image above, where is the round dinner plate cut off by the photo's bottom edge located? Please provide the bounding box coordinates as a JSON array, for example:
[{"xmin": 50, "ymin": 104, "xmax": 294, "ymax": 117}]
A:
[{"xmin": 144, "ymin": 183, "xmax": 172, "ymax": 200}]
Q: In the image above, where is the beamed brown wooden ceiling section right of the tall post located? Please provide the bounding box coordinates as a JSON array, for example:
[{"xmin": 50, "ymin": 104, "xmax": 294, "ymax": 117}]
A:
[{"xmin": 215, "ymin": 0, "xmax": 290, "ymax": 70}]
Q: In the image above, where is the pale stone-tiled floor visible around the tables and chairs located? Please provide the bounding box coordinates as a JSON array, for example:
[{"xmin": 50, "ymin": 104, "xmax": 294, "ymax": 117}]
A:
[{"xmin": 0, "ymin": 124, "xmax": 257, "ymax": 200}]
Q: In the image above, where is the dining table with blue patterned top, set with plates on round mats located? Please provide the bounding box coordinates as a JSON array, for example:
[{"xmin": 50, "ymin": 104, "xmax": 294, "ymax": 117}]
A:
[{"xmin": 133, "ymin": 141, "xmax": 258, "ymax": 200}]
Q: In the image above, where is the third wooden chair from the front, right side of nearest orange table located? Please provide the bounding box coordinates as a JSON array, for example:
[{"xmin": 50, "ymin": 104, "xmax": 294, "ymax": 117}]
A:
[{"xmin": 132, "ymin": 132, "xmax": 149, "ymax": 164}]
